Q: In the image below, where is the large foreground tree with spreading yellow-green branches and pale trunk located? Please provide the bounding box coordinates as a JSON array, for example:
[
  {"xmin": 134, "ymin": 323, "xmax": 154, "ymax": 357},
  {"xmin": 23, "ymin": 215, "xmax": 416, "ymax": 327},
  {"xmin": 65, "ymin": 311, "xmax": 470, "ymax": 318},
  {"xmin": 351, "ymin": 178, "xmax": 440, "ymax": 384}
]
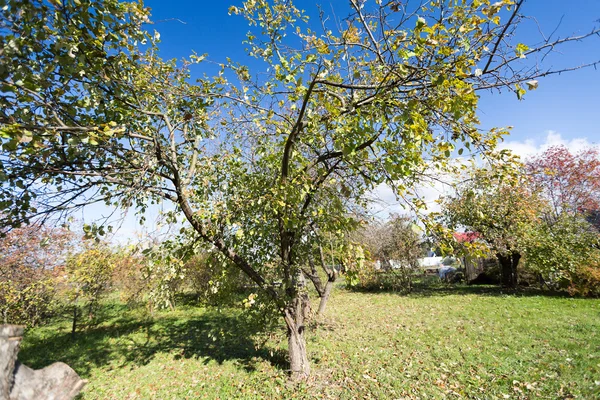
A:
[{"xmin": 0, "ymin": 0, "xmax": 597, "ymax": 378}]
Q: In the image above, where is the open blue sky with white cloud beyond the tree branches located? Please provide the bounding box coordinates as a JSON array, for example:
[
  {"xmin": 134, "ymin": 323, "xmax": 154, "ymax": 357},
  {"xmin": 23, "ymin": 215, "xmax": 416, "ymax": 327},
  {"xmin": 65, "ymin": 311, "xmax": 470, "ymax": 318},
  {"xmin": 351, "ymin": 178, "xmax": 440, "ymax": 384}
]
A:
[{"xmin": 92, "ymin": 0, "xmax": 600, "ymax": 237}]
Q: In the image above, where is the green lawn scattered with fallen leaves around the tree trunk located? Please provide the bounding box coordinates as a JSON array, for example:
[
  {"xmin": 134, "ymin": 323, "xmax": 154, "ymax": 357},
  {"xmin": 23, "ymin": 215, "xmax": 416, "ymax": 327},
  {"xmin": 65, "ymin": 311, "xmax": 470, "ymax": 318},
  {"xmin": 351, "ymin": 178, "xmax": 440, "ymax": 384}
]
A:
[{"xmin": 20, "ymin": 287, "xmax": 600, "ymax": 399}]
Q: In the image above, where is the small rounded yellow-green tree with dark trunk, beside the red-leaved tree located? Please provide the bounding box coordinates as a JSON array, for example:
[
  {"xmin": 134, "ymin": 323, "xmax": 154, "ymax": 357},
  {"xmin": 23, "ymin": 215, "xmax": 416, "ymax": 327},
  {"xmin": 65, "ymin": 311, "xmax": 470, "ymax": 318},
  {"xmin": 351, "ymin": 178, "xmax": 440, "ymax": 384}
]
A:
[{"xmin": 441, "ymin": 169, "xmax": 543, "ymax": 288}]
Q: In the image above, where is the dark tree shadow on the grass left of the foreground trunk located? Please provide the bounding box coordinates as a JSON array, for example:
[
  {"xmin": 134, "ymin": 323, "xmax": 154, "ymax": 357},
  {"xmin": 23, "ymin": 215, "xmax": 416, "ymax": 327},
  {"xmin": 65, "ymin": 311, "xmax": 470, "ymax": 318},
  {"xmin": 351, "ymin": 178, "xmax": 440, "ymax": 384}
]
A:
[{"xmin": 19, "ymin": 304, "xmax": 287, "ymax": 378}]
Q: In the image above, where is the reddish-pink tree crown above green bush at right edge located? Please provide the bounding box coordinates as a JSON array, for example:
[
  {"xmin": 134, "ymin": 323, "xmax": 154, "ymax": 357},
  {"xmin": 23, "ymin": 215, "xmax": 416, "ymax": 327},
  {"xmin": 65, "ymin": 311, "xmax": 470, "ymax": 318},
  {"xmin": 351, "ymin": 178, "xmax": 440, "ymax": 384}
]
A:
[{"xmin": 526, "ymin": 146, "xmax": 600, "ymax": 220}]
